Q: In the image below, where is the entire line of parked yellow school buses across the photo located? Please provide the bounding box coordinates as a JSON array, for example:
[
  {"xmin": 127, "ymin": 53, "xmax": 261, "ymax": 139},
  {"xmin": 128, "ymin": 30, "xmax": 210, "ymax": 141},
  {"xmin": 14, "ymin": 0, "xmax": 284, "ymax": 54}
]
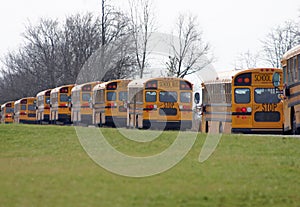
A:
[{"xmin": 1, "ymin": 45, "xmax": 300, "ymax": 134}]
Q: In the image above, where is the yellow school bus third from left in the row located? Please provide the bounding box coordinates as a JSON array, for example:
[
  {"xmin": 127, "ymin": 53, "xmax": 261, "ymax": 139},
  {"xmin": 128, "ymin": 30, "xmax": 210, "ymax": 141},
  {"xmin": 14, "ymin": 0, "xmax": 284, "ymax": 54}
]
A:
[{"xmin": 36, "ymin": 89, "xmax": 51, "ymax": 124}]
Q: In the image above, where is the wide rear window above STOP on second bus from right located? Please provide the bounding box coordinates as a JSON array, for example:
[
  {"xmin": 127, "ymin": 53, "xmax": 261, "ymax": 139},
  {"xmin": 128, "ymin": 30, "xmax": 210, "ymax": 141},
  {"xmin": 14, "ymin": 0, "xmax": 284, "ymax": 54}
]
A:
[{"xmin": 254, "ymin": 88, "xmax": 280, "ymax": 103}]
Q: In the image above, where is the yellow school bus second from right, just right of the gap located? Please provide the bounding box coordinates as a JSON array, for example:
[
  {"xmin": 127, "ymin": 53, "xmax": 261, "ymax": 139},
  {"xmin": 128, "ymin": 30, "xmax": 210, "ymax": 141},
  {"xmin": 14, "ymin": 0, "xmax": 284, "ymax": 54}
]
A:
[{"xmin": 201, "ymin": 68, "xmax": 284, "ymax": 133}]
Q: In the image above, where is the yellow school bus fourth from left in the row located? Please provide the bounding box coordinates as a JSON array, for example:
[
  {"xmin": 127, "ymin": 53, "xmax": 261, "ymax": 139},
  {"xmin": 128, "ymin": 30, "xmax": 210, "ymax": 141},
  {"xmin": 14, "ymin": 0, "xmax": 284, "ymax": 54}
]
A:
[{"xmin": 50, "ymin": 84, "xmax": 74, "ymax": 124}]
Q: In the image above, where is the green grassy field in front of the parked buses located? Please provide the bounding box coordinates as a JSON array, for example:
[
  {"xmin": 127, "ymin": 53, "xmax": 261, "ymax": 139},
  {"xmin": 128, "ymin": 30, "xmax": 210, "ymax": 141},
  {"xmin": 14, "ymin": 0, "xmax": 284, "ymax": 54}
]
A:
[{"xmin": 0, "ymin": 124, "xmax": 300, "ymax": 207}]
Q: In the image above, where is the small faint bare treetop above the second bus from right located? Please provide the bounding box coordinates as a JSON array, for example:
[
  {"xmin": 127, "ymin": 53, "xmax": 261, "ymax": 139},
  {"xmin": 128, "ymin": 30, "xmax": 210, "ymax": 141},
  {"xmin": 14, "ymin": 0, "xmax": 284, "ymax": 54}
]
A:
[{"xmin": 235, "ymin": 50, "xmax": 260, "ymax": 69}]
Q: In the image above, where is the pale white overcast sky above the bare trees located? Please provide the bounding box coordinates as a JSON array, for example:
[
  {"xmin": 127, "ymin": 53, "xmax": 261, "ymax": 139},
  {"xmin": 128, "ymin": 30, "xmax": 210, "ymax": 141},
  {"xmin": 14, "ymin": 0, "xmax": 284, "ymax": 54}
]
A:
[{"xmin": 0, "ymin": 0, "xmax": 300, "ymax": 70}]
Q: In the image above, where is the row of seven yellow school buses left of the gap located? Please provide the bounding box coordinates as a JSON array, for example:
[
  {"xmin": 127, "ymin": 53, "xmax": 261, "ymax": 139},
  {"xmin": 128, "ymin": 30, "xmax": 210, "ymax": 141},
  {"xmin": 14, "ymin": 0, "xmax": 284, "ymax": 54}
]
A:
[{"xmin": 1, "ymin": 78, "xmax": 193, "ymax": 129}]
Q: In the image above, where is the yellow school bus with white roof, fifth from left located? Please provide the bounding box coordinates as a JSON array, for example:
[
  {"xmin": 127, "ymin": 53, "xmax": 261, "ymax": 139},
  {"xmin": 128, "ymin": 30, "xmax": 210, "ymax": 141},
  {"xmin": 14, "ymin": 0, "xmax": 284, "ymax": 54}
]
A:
[{"xmin": 71, "ymin": 82, "xmax": 100, "ymax": 125}]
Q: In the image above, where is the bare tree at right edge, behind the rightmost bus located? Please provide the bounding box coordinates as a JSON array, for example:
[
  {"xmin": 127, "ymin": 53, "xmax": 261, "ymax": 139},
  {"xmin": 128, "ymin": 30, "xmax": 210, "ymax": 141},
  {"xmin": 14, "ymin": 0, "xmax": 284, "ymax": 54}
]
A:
[{"xmin": 262, "ymin": 21, "xmax": 300, "ymax": 68}]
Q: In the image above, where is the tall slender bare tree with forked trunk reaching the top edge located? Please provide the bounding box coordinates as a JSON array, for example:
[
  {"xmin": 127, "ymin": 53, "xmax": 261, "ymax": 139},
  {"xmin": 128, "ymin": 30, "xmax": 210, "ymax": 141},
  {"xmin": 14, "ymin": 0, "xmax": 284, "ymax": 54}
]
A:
[{"xmin": 129, "ymin": 0, "xmax": 155, "ymax": 78}]
